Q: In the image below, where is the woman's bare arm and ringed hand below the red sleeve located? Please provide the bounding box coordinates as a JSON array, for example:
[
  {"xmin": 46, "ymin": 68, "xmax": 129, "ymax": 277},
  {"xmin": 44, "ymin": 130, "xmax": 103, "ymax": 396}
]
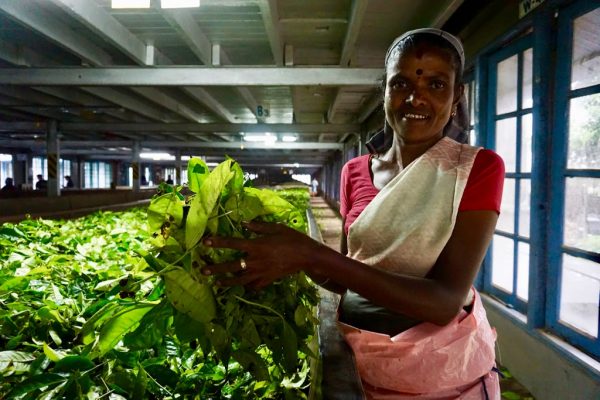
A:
[{"xmin": 203, "ymin": 211, "xmax": 498, "ymax": 325}]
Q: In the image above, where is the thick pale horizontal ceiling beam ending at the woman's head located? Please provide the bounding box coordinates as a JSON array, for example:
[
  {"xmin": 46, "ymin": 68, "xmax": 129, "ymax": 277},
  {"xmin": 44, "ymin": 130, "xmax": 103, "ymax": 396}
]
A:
[{"xmin": 0, "ymin": 67, "xmax": 383, "ymax": 86}]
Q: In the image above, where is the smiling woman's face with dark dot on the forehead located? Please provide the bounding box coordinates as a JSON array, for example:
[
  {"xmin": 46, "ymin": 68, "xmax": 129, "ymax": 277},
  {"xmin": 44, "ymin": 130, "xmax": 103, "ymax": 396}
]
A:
[{"xmin": 384, "ymin": 45, "xmax": 462, "ymax": 143}]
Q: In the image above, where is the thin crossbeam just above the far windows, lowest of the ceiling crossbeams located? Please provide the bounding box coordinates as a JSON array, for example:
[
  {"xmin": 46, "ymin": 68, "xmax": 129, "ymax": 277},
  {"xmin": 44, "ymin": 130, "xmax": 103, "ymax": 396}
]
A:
[{"xmin": 0, "ymin": 139, "xmax": 344, "ymax": 150}]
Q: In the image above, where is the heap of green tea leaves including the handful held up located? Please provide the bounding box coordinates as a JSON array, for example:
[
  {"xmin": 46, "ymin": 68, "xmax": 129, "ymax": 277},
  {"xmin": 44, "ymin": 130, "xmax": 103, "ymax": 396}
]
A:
[{"xmin": 0, "ymin": 159, "xmax": 318, "ymax": 399}]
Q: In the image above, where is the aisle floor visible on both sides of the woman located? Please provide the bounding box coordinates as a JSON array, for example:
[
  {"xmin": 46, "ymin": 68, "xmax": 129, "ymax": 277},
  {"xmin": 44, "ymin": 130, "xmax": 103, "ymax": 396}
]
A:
[{"xmin": 310, "ymin": 197, "xmax": 533, "ymax": 400}]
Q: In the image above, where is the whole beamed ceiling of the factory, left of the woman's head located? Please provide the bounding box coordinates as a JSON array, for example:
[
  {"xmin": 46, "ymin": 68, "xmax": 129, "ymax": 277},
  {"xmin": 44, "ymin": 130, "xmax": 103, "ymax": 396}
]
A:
[{"xmin": 0, "ymin": 0, "xmax": 463, "ymax": 173}]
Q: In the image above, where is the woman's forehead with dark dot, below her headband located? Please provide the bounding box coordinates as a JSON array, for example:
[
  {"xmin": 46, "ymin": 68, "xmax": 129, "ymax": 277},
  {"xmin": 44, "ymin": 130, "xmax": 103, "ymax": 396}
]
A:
[{"xmin": 386, "ymin": 44, "xmax": 456, "ymax": 75}]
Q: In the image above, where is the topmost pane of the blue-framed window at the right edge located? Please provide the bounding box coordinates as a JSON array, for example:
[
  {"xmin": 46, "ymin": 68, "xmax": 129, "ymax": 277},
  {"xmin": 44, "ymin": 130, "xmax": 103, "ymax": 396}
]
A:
[{"xmin": 571, "ymin": 8, "xmax": 600, "ymax": 89}]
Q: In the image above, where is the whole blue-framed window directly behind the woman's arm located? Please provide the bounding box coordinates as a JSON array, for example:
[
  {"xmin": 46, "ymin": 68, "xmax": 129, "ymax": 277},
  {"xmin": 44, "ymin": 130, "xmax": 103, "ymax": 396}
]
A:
[{"xmin": 484, "ymin": 36, "xmax": 533, "ymax": 313}]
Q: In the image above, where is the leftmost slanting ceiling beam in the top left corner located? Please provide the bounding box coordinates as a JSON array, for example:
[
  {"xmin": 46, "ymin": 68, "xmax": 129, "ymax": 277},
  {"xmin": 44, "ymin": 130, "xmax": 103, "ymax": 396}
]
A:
[{"xmin": 0, "ymin": 1, "xmax": 112, "ymax": 65}]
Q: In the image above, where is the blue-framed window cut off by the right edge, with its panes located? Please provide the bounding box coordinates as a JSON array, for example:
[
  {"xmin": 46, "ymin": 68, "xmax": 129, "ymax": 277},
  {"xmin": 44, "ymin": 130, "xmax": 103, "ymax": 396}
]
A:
[{"xmin": 546, "ymin": 2, "xmax": 600, "ymax": 358}]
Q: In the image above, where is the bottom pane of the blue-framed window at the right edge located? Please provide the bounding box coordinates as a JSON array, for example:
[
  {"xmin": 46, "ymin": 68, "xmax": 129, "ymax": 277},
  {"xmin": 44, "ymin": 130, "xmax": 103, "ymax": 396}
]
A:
[{"xmin": 559, "ymin": 254, "xmax": 600, "ymax": 337}]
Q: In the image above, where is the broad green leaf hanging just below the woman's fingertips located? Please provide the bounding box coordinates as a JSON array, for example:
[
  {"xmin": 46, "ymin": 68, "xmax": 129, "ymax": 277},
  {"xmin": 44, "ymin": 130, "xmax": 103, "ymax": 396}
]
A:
[{"xmin": 164, "ymin": 269, "xmax": 217, "ymax": 322}]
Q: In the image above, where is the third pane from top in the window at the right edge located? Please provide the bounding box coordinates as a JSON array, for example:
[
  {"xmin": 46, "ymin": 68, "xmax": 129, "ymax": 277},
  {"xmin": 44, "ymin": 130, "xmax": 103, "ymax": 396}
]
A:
[{"xmin": 563, "ymin": 178, "xmax": 600, "ymax": 253}]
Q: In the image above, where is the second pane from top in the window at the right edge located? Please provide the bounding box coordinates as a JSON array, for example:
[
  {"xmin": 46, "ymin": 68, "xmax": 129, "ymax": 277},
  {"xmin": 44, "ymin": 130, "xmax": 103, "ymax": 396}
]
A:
[{"xmin": 567, "ymin": 94, "xmax": 600, "ymax": 169}]
